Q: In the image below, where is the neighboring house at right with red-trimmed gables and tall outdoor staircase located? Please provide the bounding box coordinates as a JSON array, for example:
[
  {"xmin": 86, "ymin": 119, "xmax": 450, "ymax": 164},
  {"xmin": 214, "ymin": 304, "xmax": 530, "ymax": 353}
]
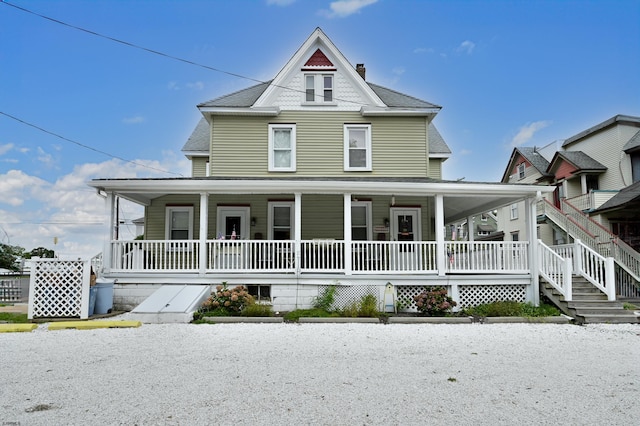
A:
[{"xmin": 498, "ymin": 115, "xmax": 640, "ymax": 297}]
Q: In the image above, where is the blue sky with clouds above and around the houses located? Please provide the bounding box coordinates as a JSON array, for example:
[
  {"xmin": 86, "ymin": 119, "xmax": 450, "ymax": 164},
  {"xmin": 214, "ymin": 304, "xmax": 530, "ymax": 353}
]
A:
[{"xmin": 0, "ymin": 0, "xmax": 640, "ymax": 257}]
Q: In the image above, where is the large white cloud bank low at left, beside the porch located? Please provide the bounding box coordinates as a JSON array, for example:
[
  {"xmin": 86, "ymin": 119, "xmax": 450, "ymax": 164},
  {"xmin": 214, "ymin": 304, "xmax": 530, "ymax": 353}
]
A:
[{"xmin": 0, "ymin": 151, "xmax": 190, "ymax": 258}]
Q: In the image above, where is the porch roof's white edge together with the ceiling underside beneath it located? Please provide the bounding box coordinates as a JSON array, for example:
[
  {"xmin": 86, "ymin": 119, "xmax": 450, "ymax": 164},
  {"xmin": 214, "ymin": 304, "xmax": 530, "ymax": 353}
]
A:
[{"xmin": 88, "ymin": 177, "xmax": 554, "ymax": 222}]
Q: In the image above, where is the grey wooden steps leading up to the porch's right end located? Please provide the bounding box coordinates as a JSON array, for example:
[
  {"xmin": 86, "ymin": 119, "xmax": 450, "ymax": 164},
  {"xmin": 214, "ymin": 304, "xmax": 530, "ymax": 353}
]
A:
[{"xmin": 540, "ymin": 275, "xmax": 640, "ymax": 324}]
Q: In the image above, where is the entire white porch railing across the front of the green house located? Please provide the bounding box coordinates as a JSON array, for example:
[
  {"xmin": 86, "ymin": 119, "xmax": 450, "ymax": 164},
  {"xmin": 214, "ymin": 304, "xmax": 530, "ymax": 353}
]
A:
[{"xmin": 110, "ymin": 239, "xmax": 529, "ymax": 274}]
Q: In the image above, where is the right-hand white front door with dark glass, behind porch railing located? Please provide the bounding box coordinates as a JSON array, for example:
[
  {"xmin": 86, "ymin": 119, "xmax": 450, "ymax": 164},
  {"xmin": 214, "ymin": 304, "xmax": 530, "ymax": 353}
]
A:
[{"xmin": 389, "ymin": 207, "xmax": 422, "ymax": 271}]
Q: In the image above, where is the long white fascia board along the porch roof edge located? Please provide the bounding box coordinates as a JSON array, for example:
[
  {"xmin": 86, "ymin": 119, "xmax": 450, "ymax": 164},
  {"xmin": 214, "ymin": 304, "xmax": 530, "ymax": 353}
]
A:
[{"xmin": 88, "ymin": 179, "xmax": 555, "ymax": 198}]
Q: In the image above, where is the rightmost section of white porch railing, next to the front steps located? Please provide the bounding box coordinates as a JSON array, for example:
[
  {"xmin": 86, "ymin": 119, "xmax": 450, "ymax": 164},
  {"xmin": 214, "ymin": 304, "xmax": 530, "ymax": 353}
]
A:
[{"xmin": 447, "ymin": 241, "xmax": 529, "ymax": 273}]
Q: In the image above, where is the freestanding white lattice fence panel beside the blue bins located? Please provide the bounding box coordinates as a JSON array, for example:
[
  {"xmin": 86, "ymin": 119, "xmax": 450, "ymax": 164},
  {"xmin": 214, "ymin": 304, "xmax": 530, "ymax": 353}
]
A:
[{"xmin": 29, "ymin": 259, "xmax": 91, "ymax": 318}]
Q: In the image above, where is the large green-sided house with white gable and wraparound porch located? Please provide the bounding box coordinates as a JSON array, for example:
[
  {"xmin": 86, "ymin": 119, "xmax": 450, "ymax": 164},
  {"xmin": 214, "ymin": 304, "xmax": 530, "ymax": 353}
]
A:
[{"xmin": 89, "ymin": 28, "xmax": 553, "ymax": 311}]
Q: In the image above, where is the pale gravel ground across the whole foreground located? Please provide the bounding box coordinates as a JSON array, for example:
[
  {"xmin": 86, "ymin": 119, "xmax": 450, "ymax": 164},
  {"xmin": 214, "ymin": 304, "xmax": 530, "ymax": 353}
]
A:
[{"xmin": 0, "ymin": 324, "xmax": 640, "ymax": 426}]
